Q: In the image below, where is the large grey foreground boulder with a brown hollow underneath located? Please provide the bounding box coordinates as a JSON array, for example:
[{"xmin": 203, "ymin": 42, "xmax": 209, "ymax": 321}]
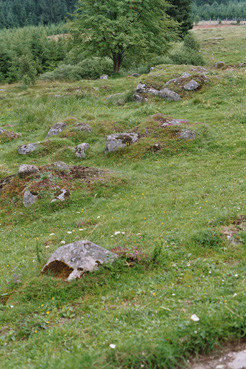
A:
[{"xmin": 41, "ymin": 240, "xmax": 118, "ymax": 281}]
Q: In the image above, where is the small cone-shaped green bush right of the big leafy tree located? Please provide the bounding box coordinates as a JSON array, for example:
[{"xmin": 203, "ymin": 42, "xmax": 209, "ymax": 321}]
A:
[{"xmin": 170, "ymin": 33, "xmax": 205, "ymax": 65}]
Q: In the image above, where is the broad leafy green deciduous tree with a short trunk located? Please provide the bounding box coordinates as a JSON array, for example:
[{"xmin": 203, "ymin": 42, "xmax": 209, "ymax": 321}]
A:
[{"xmin": 71, "ymin": 0, "xmax": 177, "ymax": 73}]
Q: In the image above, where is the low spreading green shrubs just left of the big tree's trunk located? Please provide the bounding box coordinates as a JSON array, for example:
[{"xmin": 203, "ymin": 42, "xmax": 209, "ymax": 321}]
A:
[{"xmin": 41, "ymin": 57, "xmax": 112, "ymax": 81}]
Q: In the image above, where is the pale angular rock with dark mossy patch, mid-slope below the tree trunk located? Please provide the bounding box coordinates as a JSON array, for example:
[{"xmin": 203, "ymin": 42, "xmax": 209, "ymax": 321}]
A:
[{"xmin": 105, "ymin": 132, "xmax": 139, "ymax": 154}]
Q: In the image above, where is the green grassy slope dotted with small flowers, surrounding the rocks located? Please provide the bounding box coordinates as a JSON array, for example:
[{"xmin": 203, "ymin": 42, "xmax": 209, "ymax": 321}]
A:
[{"xmin": 0, "ymin": 27, "xmax": 246, "ymax": 369}]
